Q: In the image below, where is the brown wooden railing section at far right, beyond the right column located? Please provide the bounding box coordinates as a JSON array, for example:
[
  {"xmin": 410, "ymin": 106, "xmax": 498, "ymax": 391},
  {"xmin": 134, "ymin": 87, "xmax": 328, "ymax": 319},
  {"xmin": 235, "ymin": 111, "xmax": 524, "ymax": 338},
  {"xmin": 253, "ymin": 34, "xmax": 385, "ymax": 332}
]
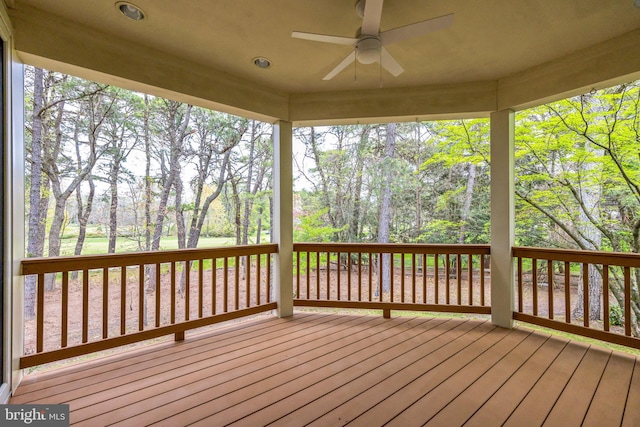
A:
[{"xmin": 513, "ymin": 247, "xmax": 640, "ymax": 348}]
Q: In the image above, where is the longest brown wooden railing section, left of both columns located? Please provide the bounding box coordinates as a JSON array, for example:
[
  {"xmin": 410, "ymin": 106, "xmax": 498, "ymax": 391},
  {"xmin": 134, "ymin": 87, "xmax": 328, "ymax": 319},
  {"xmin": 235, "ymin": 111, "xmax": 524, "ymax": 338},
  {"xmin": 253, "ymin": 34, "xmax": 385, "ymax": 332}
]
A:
[{"xmin": 20, "ymin": 244, "xmax": 277, "ymax": 368}]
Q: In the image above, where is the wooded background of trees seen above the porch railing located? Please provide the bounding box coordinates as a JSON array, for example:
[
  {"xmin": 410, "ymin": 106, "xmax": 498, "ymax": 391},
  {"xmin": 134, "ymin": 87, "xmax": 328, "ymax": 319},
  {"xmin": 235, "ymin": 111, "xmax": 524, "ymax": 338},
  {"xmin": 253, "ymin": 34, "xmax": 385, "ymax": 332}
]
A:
[{"xmin": 25, "ymin": 67, "xmax": 640, "ymax": 333}]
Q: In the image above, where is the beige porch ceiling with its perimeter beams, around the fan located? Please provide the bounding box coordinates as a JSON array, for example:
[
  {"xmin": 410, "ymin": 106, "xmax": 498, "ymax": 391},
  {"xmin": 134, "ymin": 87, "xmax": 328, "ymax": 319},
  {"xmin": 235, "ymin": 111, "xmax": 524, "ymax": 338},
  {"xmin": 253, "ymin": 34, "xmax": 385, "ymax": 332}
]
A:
[{"xmin": 5, "ymin": 0, "xmax": 640, "ymax": 122}]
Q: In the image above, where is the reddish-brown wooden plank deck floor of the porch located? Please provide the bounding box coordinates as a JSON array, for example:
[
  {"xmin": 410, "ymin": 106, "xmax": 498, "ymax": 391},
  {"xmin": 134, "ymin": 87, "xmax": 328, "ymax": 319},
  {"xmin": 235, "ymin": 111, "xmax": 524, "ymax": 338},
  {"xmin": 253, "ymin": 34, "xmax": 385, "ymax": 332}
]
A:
[{"xmin": 11, "ymin": 313, "xmax": 640, "ymax": 427}]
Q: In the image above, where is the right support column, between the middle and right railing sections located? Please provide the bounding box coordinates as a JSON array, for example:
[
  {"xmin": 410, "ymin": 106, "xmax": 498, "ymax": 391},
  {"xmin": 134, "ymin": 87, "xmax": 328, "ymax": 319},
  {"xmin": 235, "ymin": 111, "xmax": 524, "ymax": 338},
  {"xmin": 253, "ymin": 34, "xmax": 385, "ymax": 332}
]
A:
[{"xmin": 491, "ymin": 110, "xmax": 515, "ymax": 328}]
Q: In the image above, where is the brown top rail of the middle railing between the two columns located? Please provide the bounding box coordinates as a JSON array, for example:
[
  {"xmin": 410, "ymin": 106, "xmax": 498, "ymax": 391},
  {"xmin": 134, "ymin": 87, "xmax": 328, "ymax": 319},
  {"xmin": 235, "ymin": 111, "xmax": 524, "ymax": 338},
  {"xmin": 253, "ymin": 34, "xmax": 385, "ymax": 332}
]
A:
[{"xmin": 293, "ymin": 242, "xmax": 491, "ymax": 255}]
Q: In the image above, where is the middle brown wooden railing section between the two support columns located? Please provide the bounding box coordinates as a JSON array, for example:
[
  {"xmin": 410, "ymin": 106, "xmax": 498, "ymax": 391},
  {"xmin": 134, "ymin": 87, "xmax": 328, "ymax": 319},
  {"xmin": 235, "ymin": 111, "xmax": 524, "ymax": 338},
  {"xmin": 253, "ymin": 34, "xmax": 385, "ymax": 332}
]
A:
[{"xmin": 293, "ymin": 243, "xmax": 491, "ymax": 317}]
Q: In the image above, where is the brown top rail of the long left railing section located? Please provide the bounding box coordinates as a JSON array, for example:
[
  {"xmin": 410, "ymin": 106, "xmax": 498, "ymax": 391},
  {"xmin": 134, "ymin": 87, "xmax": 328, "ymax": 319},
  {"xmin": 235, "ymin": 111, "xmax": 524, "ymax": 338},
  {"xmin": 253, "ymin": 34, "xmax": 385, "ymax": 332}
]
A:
[{"xmin": 21, "ymin": 243, "xmax": 278, "ymax": 275}]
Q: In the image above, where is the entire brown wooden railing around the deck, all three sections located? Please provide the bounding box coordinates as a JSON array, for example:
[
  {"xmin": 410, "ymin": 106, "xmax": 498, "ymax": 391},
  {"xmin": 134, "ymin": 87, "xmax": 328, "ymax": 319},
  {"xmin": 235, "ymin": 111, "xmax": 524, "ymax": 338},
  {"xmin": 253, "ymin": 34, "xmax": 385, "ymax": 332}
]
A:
[{"xmin": 20, "ymin": 243, "xmax": 640, "ymax": 368}]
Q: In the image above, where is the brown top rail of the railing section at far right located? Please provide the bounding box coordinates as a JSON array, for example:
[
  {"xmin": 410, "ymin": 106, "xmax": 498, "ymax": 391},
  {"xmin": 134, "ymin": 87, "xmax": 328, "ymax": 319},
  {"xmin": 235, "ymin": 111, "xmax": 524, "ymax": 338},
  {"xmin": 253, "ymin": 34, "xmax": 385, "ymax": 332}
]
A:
[{"xmin": 512, "ymin": 246, "xmax": 640, "ymax": 267}]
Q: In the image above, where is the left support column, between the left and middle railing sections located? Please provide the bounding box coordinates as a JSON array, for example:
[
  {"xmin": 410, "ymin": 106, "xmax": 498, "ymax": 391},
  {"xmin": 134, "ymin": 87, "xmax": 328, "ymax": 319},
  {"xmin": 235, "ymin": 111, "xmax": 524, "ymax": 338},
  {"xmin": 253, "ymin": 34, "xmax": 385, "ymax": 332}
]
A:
[{"xmin": 272, "ymin": 121, "xmax": 293, "ymax": 317}]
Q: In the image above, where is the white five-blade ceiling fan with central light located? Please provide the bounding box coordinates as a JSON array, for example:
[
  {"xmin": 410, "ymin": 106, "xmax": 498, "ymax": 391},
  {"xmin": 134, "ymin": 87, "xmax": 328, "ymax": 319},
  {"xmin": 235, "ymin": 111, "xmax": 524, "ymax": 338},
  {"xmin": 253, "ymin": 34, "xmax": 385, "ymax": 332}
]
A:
[{"xmin": 291, "ymin": 0, "xmax": 453, "ymax": 80}]
